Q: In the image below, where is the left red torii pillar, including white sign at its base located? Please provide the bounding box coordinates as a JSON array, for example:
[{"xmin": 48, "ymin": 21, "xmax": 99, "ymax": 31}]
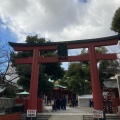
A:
[{"xmin": 26, "ymin": 49, "xmax": 39, "ymax": 120}]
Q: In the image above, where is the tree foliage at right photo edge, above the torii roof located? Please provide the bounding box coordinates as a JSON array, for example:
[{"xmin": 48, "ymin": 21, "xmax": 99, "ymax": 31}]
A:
[{"xmin": 111, "ymin": 7, "xmax": 120, "ymax": 34}]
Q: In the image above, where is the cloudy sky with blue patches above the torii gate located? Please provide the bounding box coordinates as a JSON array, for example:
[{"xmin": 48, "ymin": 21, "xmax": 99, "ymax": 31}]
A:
[{"xmin": 0, "ymin": 0, "xmax": 120, "ymax": 69}]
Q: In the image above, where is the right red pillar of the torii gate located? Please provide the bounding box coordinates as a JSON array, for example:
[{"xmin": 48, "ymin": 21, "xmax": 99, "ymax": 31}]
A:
[{"xmin": 89, "ymin": 45, "xmax": 103, "ymax": 110}]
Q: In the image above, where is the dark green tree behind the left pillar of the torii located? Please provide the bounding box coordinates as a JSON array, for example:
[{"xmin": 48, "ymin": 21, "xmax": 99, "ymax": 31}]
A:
[{"xmin": 11, "ymin": 35, "xmax": 64, "ymax": 94}]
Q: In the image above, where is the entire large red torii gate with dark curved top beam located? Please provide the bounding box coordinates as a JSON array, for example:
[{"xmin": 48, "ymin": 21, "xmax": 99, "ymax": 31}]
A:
[{"xmin": 9, "ymin": 35, "xmax": 120, "ymax": 119}]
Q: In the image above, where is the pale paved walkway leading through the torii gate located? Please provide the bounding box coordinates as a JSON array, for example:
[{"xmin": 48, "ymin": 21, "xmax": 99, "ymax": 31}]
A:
[{"xmin": 39, "ymin": 106, "xmax": 93, "ymax": 120}]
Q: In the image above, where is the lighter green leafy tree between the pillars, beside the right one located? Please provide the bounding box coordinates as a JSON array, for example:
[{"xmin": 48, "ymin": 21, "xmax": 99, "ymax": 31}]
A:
[{"xmin": 66, "ymin": 62, "xmax": 91, "ymax": 95}]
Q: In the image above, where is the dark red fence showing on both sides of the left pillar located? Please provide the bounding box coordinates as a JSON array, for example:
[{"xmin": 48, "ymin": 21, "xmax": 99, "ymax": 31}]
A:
[{"xmin": 16, "ymin": 98, "xmax": 43, "ymax": 112}]
